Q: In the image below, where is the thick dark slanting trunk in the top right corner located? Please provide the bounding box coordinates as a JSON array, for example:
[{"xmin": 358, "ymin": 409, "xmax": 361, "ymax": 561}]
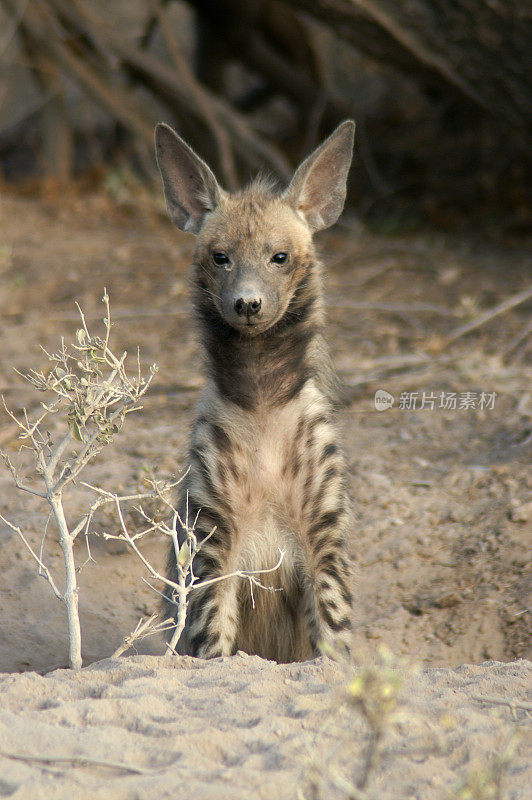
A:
[{"xmin": 283, "ymin": 0, "xmax": 532, "ymax": 126}]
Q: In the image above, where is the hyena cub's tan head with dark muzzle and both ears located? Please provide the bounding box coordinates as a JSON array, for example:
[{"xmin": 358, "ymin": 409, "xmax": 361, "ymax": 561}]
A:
[{"xmin": 155, "ymin": 120, "xmax": 355, "ymax": 336}]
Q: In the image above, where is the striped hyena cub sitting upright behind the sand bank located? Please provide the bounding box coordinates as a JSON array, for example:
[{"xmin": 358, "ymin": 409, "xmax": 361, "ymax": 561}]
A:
[{"xmin": 155, "ymin": 121, "xmax": 355, "ymax": 661}]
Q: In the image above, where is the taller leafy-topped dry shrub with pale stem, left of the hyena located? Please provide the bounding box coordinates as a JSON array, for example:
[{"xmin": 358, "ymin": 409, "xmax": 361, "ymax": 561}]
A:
[{"xmin": 1, "ymin": 292, "xmax": 157, "ymax": 669}]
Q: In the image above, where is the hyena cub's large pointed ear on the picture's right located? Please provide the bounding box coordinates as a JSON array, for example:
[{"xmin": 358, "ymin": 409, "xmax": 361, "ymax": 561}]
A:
[{"xmin": 284, "ymin": 120, "xmax": 355, "ymax": 231}]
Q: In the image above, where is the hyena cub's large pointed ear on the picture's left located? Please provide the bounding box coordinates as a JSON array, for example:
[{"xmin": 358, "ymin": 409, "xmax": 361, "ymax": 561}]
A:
[{"xmin": 155, "ymin": 122, "xmax": 224, "ymax": 233}]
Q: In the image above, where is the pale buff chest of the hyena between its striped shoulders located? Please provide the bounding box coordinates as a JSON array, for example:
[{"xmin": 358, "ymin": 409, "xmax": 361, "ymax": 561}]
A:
[{"xmin": 196, "ymin": 385, "xmax": 341, "ymax": 569}]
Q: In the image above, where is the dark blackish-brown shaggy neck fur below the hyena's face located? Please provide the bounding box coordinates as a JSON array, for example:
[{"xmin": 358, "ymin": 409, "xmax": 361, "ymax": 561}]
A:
[{"xmin": 194, "ymin": 263, "xmax": 322, "ymax": 410}]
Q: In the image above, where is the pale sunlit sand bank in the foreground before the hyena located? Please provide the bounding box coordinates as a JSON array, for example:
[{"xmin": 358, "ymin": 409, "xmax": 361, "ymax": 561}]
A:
[{"xmin": 0, "ymin": 655, "xmax": 532, "ymax": 800}]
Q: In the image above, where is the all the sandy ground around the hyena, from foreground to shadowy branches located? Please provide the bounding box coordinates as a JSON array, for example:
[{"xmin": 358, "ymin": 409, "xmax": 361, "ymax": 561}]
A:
[{"xmin": 0, "ymin": 195, "xmax": 532, "ymax": 800}]
